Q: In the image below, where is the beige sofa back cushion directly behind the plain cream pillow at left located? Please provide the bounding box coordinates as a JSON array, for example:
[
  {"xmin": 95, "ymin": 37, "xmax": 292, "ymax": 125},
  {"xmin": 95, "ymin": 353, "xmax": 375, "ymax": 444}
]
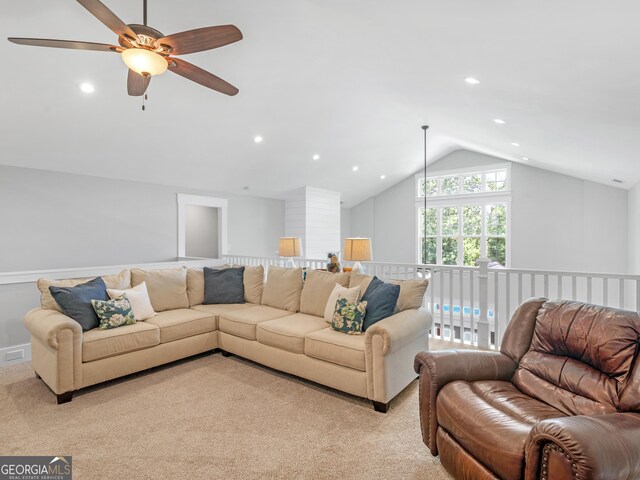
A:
[{"xmin": 131, "ymin": 267, "xmax": 189, "ymax": 312}]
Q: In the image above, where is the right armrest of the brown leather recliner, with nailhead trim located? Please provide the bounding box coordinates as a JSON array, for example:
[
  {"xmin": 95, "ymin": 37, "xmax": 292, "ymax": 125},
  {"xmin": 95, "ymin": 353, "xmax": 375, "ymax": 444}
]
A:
[{"xmin": 525, "ymin": 413, "xmax": 640, "ymax": 480}]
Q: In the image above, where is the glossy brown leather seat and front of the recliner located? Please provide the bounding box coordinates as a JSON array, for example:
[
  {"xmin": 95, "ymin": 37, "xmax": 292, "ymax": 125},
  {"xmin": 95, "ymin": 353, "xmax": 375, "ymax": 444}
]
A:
[{"xmin": 436, "ymin": 381, "xmax": 565, "ymax": 480}]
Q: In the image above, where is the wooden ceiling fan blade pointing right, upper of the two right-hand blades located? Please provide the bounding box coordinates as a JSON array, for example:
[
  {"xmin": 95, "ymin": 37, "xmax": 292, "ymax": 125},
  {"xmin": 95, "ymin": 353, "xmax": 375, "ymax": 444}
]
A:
[{"xmin": 158, "ymin": 25, "xmax": 242, "ymax": 55}]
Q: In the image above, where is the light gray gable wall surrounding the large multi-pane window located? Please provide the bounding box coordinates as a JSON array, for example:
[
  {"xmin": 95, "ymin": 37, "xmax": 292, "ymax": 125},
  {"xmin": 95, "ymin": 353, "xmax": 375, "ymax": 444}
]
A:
[{"xmin": 349, "ymin": 150, "xmax": 628, "ymax": 273}]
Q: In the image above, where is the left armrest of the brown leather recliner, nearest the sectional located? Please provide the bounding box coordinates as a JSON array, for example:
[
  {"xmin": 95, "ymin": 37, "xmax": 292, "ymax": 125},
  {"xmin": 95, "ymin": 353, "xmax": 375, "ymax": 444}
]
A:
[{"xmin": 414, "ymin": 350, "xmax": 516, "ymax": 456}]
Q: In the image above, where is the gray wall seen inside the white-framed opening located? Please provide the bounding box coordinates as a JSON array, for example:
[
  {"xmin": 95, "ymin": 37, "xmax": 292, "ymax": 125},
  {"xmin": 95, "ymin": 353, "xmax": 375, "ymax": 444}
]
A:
[{"xmin": 184, "ymin": 205, "xmax": 219, "ymax": 258}]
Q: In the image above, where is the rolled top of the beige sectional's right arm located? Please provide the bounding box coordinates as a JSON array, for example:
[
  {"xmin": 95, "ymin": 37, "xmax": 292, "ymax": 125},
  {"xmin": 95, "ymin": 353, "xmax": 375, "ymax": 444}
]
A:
[{"xmin": 364, "ymin": 308, "xmax": 432, "ymax": 355}]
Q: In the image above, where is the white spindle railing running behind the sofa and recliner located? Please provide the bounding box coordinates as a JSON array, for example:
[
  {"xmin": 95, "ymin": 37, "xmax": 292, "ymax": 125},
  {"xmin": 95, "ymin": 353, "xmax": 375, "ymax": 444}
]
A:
[{"xmin": 224, "ymin": 255, "xmax": 640, "ymax": 349}]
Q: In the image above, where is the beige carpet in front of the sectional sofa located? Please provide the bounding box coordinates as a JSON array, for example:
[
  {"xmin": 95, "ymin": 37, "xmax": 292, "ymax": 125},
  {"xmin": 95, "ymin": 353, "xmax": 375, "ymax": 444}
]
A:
[{"xmin": 0, "ymin": 348, "xmax": 451, "ymax": 480}]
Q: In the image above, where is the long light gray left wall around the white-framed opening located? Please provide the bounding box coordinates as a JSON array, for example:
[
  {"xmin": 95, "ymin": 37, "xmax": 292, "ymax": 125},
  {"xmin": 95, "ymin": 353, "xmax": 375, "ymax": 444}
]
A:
[{"xmin": 0, "ymin": 166, "xmax": 284, "ymax": 272}]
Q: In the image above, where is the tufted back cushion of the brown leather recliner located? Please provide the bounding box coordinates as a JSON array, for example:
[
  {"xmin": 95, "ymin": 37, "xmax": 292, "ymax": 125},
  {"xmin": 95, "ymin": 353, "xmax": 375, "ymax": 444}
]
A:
[{"xmin": 513, "ymin": 301, "xmax": 640, "ymax": 415}]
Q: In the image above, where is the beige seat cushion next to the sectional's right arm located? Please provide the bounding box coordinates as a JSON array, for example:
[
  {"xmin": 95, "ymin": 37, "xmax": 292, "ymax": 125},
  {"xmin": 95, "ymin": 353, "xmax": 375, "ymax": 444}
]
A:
[{"xmin": 304, "ymin": 328, "xmax": 366, "ymax": 372}]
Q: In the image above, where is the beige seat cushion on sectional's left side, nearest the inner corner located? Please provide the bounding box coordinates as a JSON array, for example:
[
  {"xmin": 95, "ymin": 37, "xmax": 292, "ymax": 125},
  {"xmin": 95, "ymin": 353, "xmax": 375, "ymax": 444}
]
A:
[{"xmin": 146, "ymin": 308, "xmax": 218, "ymax": 343}]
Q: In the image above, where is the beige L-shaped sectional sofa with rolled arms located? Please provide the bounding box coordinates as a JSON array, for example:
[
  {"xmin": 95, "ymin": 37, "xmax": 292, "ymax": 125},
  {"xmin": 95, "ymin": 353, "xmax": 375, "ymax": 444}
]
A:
[{"xmin": 24, "ymin": 266, "xmax": 431, "ymax": 412}]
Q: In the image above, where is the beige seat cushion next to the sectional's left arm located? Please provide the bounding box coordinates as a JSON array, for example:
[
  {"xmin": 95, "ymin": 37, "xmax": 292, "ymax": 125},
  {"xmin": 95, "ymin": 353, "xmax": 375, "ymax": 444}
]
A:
[{"xmin": 82, "ymin": 322, "xmax": 160, "ymax": 362}]
